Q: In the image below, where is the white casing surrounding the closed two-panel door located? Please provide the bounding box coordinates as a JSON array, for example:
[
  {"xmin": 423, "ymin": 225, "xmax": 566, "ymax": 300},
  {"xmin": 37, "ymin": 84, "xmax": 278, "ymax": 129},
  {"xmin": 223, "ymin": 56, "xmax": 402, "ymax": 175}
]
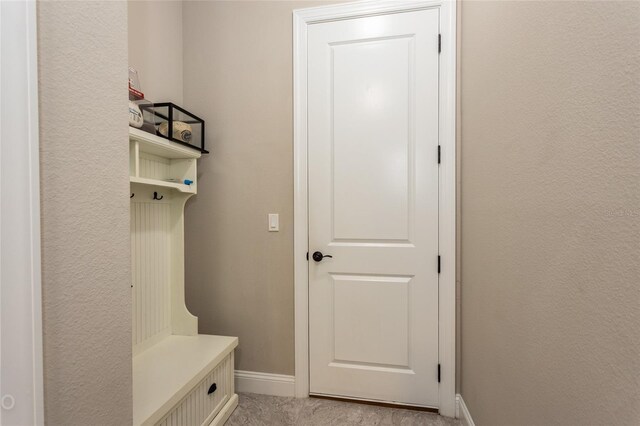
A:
[{"xmin": 293, "ymin": 0, "xmax": 456, "ymax": 417}]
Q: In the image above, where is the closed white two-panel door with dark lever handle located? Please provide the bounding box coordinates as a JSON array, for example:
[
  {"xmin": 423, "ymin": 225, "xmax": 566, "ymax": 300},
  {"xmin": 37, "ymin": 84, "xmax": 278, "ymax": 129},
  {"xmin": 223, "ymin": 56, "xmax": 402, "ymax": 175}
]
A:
[{"xmin": 308, "ymin": 9, "xmax": 439, "ymax": 407}]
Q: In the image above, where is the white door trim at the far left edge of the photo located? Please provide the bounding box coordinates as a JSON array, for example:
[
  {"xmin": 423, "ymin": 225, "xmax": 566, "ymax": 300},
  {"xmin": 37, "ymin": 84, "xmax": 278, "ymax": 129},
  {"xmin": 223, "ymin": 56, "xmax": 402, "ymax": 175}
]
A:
[{"xmin": 0, "ymin": 0, "xmax": 44, "ymax": 425}]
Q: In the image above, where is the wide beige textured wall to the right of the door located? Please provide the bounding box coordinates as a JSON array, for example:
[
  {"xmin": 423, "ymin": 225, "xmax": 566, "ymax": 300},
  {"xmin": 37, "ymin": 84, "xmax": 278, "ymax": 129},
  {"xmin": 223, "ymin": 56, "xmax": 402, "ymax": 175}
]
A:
[{"xmin": 461, "ymin": 2, "xmax": 640, "ymax": 426}]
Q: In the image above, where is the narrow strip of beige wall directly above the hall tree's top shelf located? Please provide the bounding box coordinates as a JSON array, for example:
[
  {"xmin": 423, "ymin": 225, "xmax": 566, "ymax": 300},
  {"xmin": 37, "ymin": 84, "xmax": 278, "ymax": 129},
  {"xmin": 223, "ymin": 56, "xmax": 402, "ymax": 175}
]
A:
[{"xmin": 127, "ymin": 0, "xmax": 183, "ymax": 105}]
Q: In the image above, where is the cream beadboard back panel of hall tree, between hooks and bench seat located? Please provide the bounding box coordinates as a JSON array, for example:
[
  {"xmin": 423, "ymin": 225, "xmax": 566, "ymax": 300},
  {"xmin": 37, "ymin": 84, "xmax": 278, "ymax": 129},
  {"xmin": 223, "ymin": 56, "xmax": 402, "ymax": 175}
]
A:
[{"xmin": 131, "ymin": 198, "xmax": 171, "ymax": 351}]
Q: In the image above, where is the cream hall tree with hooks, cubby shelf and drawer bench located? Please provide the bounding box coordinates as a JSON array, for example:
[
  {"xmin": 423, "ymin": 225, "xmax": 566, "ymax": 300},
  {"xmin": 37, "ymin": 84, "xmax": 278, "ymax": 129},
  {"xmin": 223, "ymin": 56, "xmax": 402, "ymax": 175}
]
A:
[{"xmin": 129, "ymin": 128, "xmax": 238, "ymax": 426}]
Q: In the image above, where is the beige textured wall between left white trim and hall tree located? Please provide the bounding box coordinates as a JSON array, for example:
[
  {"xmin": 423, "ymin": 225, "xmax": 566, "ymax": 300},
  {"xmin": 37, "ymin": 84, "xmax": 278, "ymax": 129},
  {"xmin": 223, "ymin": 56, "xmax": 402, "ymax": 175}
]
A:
[{"xmin": 38, "ymin": 1, "xmax": 132, "ymax": 426}]
